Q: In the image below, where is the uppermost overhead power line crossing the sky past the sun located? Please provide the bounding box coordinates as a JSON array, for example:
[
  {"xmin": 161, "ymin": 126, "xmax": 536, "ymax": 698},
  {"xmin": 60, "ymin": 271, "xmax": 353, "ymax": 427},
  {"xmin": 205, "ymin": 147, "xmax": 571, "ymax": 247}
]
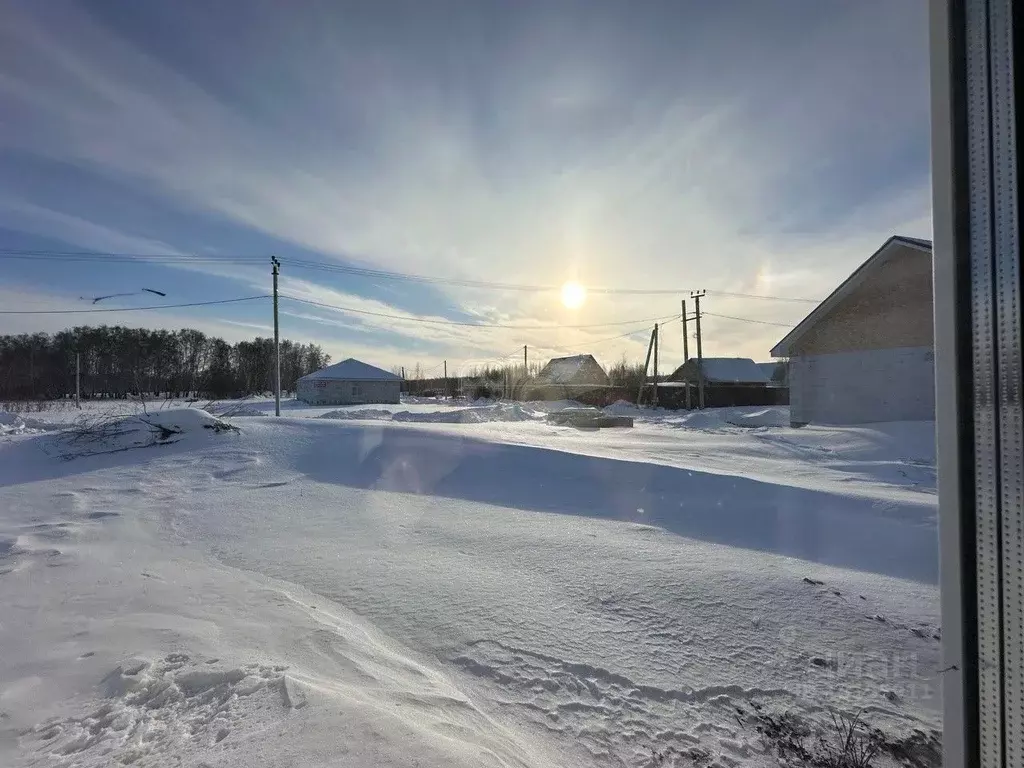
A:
[{"xmin": 0, "ymin": 249, "xmax": 819, "ymax": 304}]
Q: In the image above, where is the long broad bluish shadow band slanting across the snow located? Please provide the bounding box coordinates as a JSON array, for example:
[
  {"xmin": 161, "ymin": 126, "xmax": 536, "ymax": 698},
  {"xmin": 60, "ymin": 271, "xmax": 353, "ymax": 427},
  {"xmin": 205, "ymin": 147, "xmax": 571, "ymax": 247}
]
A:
[{"xmin": 297, "ymin": 425, "xmax": 938, "ymax": 583}]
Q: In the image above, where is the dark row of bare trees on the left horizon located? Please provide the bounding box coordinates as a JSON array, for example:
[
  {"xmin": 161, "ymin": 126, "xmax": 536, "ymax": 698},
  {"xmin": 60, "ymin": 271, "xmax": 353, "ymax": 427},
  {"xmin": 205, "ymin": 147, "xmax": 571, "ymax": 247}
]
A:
[{"xmin": 0, "ymin": 326, "xmax": 331, "ymax": 399}]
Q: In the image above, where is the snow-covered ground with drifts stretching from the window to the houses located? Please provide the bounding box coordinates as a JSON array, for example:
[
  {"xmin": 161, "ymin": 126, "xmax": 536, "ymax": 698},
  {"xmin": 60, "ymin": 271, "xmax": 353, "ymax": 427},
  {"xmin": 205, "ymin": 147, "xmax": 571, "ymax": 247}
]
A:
[{"xmin": 0, "ymin": 399, "xmax": 940, "ymax": 768}]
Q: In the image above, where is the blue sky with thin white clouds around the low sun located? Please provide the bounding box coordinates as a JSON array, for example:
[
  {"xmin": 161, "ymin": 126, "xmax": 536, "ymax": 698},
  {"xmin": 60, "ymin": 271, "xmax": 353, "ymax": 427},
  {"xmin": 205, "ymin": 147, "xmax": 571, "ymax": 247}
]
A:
[{"xmin": 0, "ymin": 0, "xmax": 931, "ymax": 368}]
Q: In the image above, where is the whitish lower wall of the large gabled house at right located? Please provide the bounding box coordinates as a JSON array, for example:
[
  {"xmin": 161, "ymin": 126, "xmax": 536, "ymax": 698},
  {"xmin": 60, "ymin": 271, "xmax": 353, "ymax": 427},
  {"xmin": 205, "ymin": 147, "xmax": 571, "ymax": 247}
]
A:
[{"xmin": 790, "ymin": 347, "xmax": 935, "ymax": 424}]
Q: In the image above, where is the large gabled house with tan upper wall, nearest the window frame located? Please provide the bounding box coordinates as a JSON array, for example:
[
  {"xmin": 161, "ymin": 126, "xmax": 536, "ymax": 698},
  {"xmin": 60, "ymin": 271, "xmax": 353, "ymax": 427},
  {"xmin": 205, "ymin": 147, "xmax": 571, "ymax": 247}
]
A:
[{"xmin": 771, "ymin": 236, "xmax": 935, "ymax": 425}]
